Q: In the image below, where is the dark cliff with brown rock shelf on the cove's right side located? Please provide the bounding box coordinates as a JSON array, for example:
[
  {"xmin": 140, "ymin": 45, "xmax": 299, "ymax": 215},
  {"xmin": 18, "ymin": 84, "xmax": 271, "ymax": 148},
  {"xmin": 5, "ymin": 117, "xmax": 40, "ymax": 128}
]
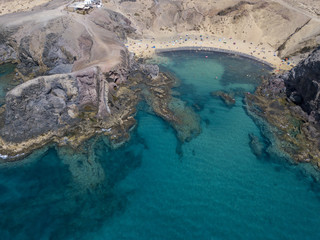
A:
[{"xmin": 246, "ymin": 47, "xmax": 320, "ymax": 166}]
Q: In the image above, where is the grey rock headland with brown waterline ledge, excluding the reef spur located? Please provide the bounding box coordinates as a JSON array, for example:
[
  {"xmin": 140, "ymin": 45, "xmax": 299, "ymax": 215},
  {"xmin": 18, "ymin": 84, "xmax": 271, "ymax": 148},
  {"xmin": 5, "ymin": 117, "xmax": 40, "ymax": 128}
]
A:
[{"xmin": 0, "ymin": 67, "xmax": 137, "ymax": 159}]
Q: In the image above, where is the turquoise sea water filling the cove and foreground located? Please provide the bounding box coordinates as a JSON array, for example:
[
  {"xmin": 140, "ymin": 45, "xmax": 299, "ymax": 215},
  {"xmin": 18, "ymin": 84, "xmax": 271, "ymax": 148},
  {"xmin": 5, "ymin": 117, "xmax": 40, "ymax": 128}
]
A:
[{"xmin": 0, "ymin": 52, "xmax": 320, "ymax": 240}]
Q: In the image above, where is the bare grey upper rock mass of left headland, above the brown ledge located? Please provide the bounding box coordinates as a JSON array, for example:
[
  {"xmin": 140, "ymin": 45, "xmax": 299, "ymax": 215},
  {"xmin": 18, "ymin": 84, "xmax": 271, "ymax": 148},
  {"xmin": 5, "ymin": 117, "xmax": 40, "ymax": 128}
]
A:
[{"xmin": 1, "ymin": 65, "xmax": 108, "ymax": 142}]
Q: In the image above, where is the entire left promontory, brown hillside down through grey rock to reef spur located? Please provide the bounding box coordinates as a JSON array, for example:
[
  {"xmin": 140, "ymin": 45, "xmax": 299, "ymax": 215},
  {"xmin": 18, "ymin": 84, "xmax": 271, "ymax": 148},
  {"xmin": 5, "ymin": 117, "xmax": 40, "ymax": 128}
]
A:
[{"xmin": 0, "ymin": 5, "xmax": 200, "ymax": 161}]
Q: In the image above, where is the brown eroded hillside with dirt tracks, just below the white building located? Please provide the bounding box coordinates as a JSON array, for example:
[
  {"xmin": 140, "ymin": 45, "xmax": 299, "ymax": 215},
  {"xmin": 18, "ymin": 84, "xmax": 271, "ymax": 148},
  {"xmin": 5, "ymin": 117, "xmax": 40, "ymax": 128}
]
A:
[{"xmin": 0, "ymin": 3, "xmax": 130, "ymax": 80}]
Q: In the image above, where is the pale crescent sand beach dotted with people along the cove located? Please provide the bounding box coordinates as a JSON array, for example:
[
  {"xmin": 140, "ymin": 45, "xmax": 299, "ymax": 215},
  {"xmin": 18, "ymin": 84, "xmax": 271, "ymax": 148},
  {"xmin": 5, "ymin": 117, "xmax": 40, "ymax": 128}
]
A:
[{"xmin": 126, "ymin": 34, "xmax": 296, "ymax": 71}]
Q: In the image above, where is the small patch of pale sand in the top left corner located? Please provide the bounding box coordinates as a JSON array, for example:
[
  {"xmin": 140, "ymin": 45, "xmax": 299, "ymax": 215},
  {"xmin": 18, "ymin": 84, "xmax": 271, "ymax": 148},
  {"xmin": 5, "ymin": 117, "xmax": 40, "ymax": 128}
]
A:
[{"xmin": 0, "ymin": 0, "xmax": 51, "ymax": 15}]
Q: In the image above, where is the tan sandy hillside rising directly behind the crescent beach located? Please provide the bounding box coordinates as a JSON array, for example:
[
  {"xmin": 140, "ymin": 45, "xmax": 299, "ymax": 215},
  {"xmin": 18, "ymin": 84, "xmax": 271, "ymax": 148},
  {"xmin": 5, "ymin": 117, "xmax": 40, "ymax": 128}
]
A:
[{"xmin": 104, "ymin": 0, "xmax": 320, "ymax": 61}]
